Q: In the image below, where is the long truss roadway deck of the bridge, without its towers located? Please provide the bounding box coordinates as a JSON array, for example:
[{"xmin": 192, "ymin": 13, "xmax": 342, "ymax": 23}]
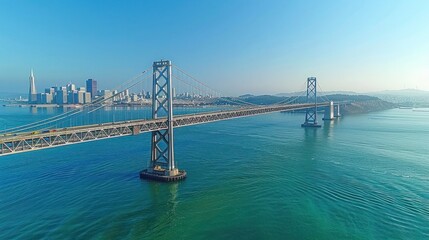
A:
[{"xmin": 0, "ymin": 102, "xmax": 329, "ymax": 156}]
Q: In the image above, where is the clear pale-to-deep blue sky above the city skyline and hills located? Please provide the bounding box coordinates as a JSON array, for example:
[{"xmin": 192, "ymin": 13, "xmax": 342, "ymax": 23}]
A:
[{"xmin": 0, "ymin": 0, "xmax": 429, "ymax": 95}]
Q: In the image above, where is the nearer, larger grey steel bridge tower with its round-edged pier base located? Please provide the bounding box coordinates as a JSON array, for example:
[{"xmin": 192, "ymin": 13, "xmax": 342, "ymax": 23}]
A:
[{"xmin": 140, "ymin": 60, "xmax": 186, "ymax": 182}]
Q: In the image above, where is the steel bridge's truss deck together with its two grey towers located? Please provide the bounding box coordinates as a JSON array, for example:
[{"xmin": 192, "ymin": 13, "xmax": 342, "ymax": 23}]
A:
[{"xmin": 0, "ymin": 60, "xmax": 339, "ymax": 181}]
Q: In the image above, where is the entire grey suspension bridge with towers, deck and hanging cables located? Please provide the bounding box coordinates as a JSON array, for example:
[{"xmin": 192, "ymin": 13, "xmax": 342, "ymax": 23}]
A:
[{"xmin": 0, "ymin": 60, "xmax": 340, "ymax": 181}]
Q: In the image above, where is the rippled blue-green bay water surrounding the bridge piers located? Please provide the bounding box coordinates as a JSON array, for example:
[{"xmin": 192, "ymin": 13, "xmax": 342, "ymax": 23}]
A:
[{"xmin": 0, "ymin": 108, "xmax": 429, "ymax": 239}]
